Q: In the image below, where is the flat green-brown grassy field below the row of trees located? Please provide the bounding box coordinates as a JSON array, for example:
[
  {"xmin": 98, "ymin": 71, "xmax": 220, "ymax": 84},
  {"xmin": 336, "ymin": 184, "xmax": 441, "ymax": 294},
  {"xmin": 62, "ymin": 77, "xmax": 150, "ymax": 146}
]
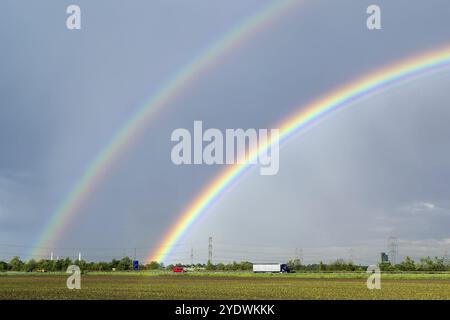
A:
[{"xmin": 0, "ymin": 273, "xmax": 450, "ymax": 300}]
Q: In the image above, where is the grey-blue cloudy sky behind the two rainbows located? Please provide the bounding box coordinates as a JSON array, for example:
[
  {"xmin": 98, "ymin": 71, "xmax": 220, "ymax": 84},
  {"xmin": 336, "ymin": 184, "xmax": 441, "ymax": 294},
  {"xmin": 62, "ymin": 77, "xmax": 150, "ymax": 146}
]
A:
[{"xmin": 0, "ymin": 0, "xmax": 450, "ymax": 262}]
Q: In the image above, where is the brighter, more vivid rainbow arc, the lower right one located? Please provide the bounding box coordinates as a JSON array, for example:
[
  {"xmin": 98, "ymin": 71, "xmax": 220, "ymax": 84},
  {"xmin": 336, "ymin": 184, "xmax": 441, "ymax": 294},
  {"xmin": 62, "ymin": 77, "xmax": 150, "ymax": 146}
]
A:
[{"xmin": 148, "ymin": 46, "xmax": 450, "ymax": 262}]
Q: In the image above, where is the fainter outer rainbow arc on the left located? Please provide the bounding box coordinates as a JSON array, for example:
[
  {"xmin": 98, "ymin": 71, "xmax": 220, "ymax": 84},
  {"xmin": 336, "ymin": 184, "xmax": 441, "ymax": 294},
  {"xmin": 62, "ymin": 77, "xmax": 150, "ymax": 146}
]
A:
[{"xmin": 30, "ymin": 0, "xmax": 303, "ymax": 257}]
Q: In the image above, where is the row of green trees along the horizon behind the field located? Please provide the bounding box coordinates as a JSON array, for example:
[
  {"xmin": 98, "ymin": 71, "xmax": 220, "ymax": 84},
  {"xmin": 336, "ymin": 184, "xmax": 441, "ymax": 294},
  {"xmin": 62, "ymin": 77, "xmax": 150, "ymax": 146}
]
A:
[{"xmin": 0, "ymin": 257, "xmax": 450, "ymax": 272}]
